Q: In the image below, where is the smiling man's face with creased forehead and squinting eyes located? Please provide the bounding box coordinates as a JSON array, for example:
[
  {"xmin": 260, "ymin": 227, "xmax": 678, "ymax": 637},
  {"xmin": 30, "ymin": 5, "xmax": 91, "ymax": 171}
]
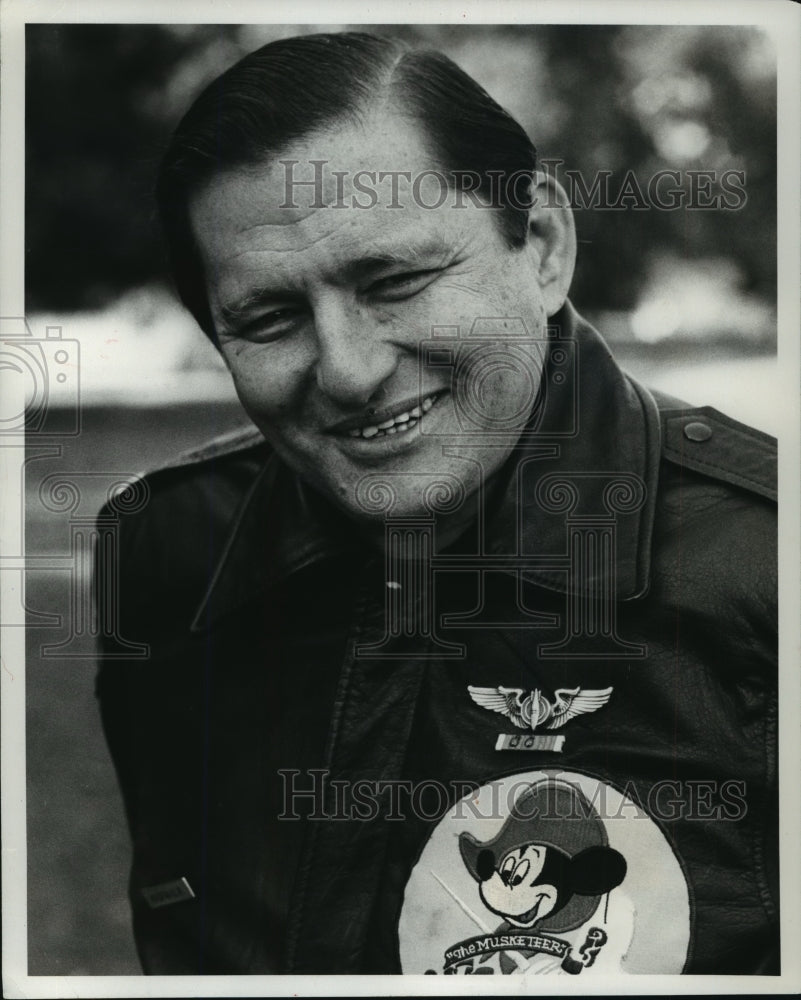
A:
[{"xmin": 190, "ymin": 114, "xmax": 560, "ymax": 520}]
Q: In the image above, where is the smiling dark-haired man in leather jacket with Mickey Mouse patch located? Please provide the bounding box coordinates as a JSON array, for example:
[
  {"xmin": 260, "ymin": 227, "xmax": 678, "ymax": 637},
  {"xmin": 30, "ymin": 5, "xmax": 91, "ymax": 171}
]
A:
[{"xmin": 98, "ymin": 34, "xmax": 778, "ymax": 975}]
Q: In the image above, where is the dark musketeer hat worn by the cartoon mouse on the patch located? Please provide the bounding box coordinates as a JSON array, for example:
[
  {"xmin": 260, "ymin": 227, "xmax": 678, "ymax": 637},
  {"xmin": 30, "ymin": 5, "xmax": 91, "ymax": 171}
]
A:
[{"xmin": 459, "ymin": 779, "xmax": 625, "ymax": 932}]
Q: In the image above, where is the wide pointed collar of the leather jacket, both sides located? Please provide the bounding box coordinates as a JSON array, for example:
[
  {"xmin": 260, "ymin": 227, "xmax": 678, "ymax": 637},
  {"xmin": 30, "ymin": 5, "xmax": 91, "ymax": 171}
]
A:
[{"xmin": 192, "ymin": 302, "xmax": 660, "ymax": 631}]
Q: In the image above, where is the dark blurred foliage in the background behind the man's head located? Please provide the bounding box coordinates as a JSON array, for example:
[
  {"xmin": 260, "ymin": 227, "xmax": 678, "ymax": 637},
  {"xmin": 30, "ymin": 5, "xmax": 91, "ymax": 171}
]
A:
[{"xmin": 26, "ymin": 24, "xmax": 776, "ymax": 310}]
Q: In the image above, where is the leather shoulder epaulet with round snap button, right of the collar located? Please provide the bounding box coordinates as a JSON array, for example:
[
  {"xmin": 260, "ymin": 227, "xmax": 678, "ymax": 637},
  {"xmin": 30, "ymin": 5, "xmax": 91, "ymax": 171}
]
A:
[{"xmin": 653, "ymin": 393, "xmax": 778, "ymax": 500}]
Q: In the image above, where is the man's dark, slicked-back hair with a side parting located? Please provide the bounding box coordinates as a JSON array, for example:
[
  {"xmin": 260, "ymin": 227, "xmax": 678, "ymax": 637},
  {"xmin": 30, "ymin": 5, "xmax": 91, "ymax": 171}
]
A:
[{"xmin": 157, "ymin": 32, "xmax": 536, "ymax": 342}]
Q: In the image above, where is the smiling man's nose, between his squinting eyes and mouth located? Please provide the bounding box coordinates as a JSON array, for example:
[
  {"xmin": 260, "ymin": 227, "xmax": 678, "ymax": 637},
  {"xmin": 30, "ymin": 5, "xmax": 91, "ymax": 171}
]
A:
[{"xmin": 314, "ymin": 299, "xmax": 398, "ymax": 406}]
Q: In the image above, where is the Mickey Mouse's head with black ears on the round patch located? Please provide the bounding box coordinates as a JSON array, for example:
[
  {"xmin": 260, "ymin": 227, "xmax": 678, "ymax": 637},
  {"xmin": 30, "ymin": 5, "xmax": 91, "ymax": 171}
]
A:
[{"xmin": 476, "ymin": 843, "xmax": 626, "ymax": 927}]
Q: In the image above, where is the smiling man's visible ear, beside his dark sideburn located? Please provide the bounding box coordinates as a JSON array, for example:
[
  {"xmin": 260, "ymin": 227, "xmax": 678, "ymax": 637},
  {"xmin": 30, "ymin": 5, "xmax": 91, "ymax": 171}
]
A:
[{"xmin": 528, "ymin": 170, "xmax": 576, "ymax": 316}]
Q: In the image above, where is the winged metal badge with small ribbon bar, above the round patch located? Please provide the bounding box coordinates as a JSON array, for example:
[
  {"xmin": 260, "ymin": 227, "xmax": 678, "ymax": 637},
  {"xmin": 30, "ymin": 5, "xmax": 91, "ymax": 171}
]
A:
[{"xmin": 467, "ymin": 684, "xmax": 613, "ymax": 752}]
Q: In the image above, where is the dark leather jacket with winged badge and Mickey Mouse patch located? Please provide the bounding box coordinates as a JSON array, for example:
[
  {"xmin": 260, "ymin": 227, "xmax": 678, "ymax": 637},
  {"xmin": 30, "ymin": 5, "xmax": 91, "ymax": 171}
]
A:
[{"xmin": 98, "ymin": 306, "xmax": 778, "ymax": 975}]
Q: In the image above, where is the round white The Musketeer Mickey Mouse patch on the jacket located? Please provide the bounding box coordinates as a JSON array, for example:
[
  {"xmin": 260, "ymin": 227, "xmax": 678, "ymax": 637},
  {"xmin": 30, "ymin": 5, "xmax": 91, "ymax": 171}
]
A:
[{"xmin": 398, "ymin": 769, "xmax": 690, "ymax": 975}]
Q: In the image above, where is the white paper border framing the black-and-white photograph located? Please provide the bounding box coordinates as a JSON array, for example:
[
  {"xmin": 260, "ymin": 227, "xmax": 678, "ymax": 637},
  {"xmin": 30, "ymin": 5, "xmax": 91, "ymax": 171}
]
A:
[{"xmin": 0, "ymin": 0, "xmax": 801, "ymax": 998}]
